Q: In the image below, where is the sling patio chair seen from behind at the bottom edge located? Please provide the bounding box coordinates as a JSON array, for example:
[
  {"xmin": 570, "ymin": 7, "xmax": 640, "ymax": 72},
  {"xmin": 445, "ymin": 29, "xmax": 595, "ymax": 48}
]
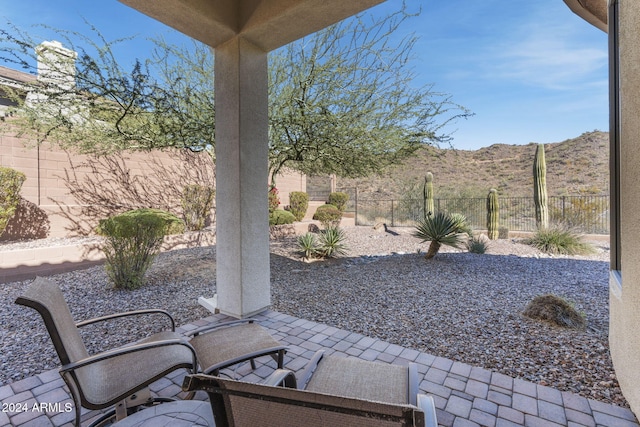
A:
[{"xmin": 182, "ymin": 354, "xmax": 438, "ymax": 427}]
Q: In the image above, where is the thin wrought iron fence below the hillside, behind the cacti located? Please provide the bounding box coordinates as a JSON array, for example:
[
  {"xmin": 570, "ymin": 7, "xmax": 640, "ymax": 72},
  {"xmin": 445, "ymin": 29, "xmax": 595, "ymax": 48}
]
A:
[{"xmin": 356, "ymin": 196, "xmax": 609, "ymax": 234}]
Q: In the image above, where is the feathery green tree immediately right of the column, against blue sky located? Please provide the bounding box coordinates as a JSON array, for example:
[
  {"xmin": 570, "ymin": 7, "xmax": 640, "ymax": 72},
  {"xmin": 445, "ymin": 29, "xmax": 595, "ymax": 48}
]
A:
[{"xmin": 269, "ymin": 6, "xmax": 470, "ymax": 181}]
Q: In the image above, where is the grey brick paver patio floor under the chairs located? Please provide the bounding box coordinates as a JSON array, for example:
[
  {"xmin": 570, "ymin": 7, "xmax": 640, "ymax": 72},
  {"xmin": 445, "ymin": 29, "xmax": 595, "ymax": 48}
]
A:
[{"xmin": 0, "ymin": 311, "xmax": 640, "ymax": 427}]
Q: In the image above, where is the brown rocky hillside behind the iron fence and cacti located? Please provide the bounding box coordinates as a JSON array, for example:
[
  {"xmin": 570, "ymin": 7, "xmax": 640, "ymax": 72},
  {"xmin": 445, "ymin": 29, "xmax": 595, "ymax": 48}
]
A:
[{"xmin": 337, "ymin": 131, "xmax": 609, "ymax": 199}]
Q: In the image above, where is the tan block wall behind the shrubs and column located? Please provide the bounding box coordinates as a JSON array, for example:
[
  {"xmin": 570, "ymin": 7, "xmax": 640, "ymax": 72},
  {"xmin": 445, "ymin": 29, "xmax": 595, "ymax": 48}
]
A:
[{"xmin": 0, "ymin": 132, "xmax": 306, "ymax": 241}]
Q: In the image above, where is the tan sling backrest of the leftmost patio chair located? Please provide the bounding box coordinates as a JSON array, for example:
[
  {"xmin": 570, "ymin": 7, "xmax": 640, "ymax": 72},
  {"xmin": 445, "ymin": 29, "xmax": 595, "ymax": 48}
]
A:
[{"xmin": 16, "ymin": 277, "xmax": 88, "ymax": 365}]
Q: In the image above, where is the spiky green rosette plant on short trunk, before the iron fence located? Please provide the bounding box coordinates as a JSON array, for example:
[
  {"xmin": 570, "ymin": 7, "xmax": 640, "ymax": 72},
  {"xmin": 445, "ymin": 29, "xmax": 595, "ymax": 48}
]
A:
[{"xmin": 413, "ymin": 212, "xmax": 468, "ymax": 259}]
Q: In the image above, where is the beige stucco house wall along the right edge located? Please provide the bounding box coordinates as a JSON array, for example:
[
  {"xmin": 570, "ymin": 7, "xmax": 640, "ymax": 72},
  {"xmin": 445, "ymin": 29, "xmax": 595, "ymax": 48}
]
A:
[{"xmin": 609, "ymin": 0, "xmax": 640, "ymax": 415}]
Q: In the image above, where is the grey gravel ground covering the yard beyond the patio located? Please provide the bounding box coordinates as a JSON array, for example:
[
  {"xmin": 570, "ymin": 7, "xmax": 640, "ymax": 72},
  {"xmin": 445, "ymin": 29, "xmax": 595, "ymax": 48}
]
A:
[{"xmin": 0, "ymin": 227, "xmax": 628, "ymax": 407}]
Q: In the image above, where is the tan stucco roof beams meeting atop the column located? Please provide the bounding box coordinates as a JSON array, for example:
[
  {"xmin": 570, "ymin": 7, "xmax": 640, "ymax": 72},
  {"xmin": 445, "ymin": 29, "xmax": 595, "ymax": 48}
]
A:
[{"xmin": 120, "ymin": 0, "xmax": 384, "ymax": 52}]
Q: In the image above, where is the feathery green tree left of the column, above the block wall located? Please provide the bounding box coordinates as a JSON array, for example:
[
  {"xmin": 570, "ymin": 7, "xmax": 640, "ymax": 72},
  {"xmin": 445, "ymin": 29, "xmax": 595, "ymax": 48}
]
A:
[{"xmin": 0, "ymin": 25, "xmax": 214, "ymax": 154}]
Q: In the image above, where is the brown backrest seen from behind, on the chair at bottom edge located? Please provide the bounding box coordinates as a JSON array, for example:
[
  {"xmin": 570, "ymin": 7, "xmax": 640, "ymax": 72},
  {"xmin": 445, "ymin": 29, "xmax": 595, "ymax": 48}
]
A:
[{"xmin": 183, "ymin": 374, "xmax": 425, "ymax": 427}]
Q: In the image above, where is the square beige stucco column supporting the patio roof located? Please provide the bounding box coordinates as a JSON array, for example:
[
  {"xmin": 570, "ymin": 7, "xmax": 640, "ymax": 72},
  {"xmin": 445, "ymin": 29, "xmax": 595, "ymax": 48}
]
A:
[{"xmin": 215, "ymin": 37, "xmax": 271, "ymax": 318}]
